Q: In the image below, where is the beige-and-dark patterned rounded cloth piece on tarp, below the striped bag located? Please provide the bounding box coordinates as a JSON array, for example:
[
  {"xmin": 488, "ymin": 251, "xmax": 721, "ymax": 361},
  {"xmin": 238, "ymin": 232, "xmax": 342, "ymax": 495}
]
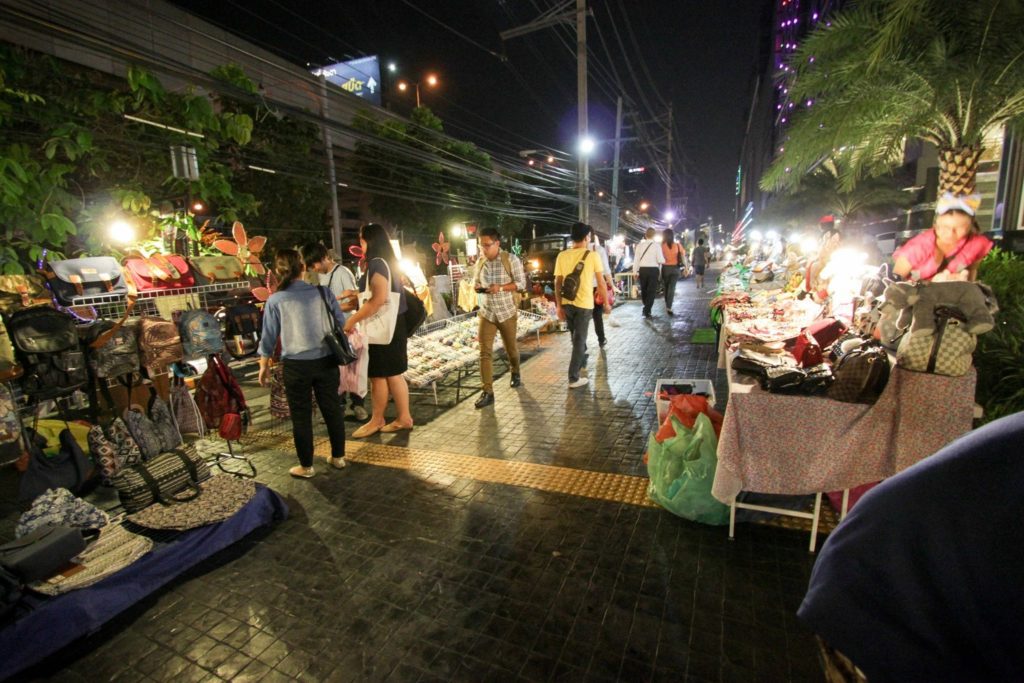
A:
[{"xmin": 127, "ymin": 474, "xmax": 256, "ymax": 531}]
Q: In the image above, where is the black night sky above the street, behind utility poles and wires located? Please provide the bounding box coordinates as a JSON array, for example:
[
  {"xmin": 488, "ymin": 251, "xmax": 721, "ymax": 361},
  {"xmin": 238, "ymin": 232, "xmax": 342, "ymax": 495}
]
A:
[{"xmin": 175, "ymin": 0, "xmax": 770, "ymax": 229}]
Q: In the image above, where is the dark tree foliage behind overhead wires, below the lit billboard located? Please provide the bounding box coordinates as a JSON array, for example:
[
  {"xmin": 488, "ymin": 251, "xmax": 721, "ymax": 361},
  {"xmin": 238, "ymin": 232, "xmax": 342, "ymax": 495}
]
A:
[{"xmin": 349, "ymin": 106, "xmax": 512, "ymax": 237}]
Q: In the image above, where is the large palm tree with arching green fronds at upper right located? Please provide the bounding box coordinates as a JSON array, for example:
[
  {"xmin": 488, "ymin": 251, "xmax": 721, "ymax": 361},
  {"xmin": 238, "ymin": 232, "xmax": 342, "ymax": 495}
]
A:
[{"xmin": 761, "ymin": 0, "xmax": 1024, "ymax": 194}]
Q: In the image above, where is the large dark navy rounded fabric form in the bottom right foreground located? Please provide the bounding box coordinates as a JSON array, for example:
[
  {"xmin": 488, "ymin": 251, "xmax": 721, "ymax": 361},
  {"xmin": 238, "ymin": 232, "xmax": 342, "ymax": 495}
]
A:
[{"xmin": 797, "ymin": 413, "xmax": 1024, "ymax": 683}]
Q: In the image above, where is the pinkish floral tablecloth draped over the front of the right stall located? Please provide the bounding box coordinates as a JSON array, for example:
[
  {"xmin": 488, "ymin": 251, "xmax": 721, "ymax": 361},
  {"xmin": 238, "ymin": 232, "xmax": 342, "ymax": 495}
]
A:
[{"xmin": 712, "ymin": 368, "xmax": 976, "ymax": 503}]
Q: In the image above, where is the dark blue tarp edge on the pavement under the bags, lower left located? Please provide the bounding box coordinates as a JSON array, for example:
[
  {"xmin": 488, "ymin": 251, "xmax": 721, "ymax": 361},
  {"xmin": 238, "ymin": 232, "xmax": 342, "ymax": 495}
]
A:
[{"xmin": 0, "ymin": 484, "xmax": 288, "ymax": 680}]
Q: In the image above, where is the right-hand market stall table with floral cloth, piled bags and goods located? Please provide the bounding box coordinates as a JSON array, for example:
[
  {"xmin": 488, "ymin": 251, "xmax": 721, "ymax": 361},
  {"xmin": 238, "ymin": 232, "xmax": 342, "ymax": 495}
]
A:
[{"xmin": 712, "ymin": 244, "xmax": 976, "ymax": 552}]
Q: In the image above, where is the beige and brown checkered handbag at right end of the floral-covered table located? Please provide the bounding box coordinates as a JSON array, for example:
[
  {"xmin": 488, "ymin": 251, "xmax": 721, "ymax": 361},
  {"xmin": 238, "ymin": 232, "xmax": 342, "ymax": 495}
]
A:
[{"xmin": 896, "ymin": 306, "xmax": 978, "ymax": 377}]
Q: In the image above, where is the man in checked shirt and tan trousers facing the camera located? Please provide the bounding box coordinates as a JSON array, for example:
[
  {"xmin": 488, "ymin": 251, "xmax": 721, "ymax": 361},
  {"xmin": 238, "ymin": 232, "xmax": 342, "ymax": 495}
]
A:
[{"xmin": 473, "ymin": 227, "xmax": 526, "ymax": 409}]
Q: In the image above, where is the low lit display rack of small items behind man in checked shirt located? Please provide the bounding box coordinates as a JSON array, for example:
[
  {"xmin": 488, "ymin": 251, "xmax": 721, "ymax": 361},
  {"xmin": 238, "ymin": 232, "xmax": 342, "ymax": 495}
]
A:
[{"xmin": 406, "ymin": 310, "xmax": 549, "ymax": 405}]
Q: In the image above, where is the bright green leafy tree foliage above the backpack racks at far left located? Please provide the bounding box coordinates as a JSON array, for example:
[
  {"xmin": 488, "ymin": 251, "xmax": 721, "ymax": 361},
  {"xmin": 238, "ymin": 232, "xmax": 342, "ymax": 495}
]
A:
[{"xmin": 0, "ymin": 45, "xmax": 327, "ymax": 272}]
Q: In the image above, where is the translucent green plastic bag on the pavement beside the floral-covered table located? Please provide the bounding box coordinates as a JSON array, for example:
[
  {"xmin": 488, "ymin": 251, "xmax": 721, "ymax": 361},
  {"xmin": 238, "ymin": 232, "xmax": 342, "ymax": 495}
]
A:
[{"xmin": 647, "ymin": 413, "xmax": 729, "ymax": 525}]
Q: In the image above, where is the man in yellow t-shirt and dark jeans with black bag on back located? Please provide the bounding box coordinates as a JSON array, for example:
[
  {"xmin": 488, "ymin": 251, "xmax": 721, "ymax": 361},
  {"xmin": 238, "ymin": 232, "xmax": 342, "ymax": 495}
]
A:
[{"xmin": 555, "ymin": 222, "xmax": 611, "ymax": 389}]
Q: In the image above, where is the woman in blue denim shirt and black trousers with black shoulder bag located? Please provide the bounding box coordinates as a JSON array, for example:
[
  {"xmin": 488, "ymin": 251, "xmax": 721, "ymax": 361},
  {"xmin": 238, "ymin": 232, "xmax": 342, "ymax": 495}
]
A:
[{"xmin": 259, "ymin": 249, "xmax": 345, "ymax": 479}]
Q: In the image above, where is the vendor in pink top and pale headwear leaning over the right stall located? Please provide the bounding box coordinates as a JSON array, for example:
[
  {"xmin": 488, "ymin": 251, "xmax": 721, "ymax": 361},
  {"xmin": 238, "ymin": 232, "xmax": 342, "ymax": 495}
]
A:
[{"xmin": 893, "ymin": 193, "xmax": 992, "ymax": 282}]
